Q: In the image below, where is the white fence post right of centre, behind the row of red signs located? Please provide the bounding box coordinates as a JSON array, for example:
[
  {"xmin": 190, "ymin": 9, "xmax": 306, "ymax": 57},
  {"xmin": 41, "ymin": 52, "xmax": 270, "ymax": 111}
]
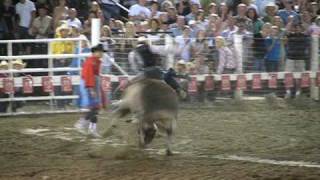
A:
[{"xmin": 233, "ymin": 34, "xmax": 243, "ymax": 100}]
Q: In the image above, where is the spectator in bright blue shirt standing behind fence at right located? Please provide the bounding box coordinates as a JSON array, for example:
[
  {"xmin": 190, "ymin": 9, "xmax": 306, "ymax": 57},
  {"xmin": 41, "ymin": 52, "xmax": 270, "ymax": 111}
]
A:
[{"xmin": 265, "ymin": 26, "xmax": 284, "ymax": 72}]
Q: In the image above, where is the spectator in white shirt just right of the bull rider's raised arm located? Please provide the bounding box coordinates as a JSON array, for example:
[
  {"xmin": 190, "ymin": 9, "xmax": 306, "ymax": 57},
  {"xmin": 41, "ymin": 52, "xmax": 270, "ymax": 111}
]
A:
[{"xmin": 175, "ymin": 26, "xmax": 192, "ymax": 62}]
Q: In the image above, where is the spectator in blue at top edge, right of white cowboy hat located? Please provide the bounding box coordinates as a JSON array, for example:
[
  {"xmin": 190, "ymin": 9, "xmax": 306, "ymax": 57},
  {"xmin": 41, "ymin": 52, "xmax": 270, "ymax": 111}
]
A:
[{"xmin": 278, "ymin": 0, "xmax": 299, "ymax": 25}]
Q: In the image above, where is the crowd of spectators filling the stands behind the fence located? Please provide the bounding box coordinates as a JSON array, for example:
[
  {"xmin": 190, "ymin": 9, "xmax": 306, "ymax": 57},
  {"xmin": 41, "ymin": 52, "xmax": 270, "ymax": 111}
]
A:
[{"xmin": 0, "ymin": 0, "xmax": 320, "ymax": 108}]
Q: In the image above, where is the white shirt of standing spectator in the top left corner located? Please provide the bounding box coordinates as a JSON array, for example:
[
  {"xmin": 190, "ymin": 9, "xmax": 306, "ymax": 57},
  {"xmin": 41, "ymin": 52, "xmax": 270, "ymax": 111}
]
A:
[{"xmin": 16, "ymin": 0, "xmax": 36, "ymax": 28}]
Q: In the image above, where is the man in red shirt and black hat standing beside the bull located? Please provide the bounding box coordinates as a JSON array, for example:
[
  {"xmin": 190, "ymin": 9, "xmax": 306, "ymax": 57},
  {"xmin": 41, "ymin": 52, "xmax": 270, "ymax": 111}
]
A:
[{"xmin": 75, "ymin": 44, "xmax": 105, "ymax": 138}]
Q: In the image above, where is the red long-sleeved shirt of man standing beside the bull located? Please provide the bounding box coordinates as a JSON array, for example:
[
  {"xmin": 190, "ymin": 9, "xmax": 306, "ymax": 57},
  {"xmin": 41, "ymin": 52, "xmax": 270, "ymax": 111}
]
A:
[{"xmin": 81, "ymin": 56, "xmax": 101, "ymax": 88}]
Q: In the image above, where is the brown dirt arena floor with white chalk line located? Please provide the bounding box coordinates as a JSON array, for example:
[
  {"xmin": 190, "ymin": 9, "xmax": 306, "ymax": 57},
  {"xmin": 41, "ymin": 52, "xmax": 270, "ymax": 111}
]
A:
[{"xmin": 0, "ymin": 98, "xmax": 320, "ymax": 180}]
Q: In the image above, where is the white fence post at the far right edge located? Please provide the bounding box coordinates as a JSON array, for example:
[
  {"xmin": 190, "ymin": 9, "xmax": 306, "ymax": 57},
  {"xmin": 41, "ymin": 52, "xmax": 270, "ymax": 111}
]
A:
[{"xmin": 310, "ymin": 35, "xmax": 319, "ymax": 100}]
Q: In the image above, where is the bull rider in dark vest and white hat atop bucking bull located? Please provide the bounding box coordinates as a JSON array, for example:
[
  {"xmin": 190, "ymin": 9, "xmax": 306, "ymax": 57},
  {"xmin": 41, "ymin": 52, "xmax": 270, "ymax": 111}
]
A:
[{"xmin": 129, "ymin": 36, "xmax": 186, "ymax": 98}]
